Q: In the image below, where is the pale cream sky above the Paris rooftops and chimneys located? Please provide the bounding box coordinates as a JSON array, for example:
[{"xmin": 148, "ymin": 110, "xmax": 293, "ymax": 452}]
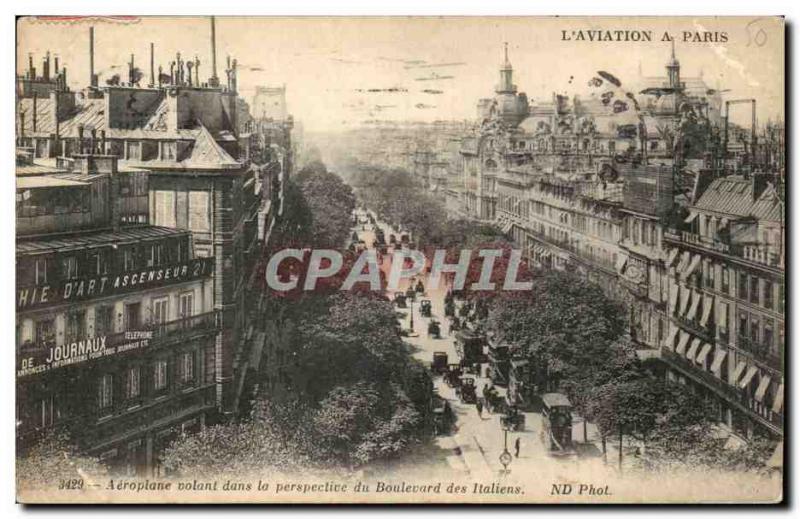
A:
[{"xmin": 17, "ymin": 17, "xmax": 784, "ymax": 132}]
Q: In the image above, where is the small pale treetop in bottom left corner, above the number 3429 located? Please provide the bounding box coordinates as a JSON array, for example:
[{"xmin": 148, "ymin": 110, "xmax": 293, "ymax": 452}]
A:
[{"xmin": 17, "ymin": 431, "xmax": 107, "ymax": 490}]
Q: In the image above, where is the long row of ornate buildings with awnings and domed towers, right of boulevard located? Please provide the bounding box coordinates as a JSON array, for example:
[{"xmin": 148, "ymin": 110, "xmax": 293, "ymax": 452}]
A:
[{"xmin": 448, "ymin": 43, "xmax": 785, "ymax": 438}]
